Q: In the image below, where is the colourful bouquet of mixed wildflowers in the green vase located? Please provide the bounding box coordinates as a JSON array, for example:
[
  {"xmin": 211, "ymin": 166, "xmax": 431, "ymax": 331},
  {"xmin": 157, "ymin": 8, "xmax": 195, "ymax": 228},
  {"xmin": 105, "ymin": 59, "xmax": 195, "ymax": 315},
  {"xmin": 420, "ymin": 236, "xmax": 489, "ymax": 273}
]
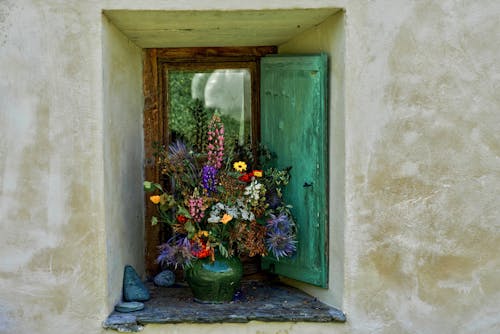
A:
[{"xmin": 144, "ymin": 114, "xmax": 297, "ymax": 297}]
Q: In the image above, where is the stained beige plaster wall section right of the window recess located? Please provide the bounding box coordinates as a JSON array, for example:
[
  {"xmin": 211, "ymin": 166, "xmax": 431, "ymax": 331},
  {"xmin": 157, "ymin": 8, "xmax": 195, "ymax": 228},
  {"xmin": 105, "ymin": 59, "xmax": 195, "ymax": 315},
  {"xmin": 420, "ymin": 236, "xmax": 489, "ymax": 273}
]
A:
[{"xmin": 344, "ymin": 1, "xmax": 500, "ymax": 334}]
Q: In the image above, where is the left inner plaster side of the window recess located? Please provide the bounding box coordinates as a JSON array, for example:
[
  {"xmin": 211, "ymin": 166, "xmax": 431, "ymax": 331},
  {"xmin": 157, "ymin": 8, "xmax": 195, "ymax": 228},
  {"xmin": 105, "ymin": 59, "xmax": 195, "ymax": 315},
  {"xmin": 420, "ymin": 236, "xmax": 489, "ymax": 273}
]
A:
[{"xmin": 102, "ymin": 16, "xmax": 144, "ymax": 307}]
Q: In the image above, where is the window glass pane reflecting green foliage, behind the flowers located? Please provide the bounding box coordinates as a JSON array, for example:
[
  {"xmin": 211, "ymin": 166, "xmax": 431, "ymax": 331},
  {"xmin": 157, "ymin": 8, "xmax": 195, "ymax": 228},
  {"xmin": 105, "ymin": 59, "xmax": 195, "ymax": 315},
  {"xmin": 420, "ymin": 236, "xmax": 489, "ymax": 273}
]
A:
[{"xmin": 167, "ymin": 69, "xmax": 251, "ymax": 150}]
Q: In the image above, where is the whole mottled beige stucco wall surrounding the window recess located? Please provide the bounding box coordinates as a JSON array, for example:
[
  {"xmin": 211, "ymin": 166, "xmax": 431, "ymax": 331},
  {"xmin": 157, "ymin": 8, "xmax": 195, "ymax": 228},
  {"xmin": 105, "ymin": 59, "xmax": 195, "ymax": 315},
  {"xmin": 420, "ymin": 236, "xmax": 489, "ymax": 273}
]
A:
[{"xmin": 0, "ymin": 0, "xmax": 500, "ymax": 333}]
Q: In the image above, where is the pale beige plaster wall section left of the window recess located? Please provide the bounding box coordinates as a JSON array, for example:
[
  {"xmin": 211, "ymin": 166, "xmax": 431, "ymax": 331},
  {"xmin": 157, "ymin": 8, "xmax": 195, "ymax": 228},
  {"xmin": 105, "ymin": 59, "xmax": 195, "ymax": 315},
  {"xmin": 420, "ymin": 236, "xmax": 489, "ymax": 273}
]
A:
[{"xmin": 0, "ymin": 1, "xmax": 107, "ymax": 334}]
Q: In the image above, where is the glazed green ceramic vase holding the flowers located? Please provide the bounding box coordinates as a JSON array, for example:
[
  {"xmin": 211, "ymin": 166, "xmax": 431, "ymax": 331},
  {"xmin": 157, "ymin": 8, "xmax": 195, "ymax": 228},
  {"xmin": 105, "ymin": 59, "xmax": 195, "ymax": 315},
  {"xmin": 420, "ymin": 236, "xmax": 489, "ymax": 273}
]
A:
[{"xmin": 186, "ymin": 256, "xmax": 243, "ymax": 304}]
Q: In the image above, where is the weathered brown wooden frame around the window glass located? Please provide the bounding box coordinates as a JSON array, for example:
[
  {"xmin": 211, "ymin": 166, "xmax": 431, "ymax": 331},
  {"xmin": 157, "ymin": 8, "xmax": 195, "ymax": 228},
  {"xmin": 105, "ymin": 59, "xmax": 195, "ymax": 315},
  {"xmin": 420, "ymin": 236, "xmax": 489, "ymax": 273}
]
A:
[{"xmin": 143, "ymin": 46, "xmax": 277, "ymax": 277}]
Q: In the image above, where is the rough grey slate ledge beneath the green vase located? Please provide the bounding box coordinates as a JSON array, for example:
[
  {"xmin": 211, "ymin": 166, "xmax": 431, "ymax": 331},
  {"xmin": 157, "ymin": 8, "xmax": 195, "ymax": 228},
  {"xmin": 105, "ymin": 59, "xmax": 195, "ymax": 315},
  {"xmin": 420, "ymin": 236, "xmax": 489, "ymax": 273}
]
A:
[{"xmin": 103, "ymin": 281, "xmax": 346, "ymax": 332}]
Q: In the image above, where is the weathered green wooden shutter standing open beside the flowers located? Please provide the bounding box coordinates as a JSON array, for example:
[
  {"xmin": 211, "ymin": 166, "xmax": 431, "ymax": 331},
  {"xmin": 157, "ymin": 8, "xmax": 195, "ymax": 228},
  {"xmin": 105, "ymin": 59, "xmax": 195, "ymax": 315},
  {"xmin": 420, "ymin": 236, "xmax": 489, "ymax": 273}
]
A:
[{"xmin": 261, "ymin": 54, "xmax": 328, "ymax": 287}]
